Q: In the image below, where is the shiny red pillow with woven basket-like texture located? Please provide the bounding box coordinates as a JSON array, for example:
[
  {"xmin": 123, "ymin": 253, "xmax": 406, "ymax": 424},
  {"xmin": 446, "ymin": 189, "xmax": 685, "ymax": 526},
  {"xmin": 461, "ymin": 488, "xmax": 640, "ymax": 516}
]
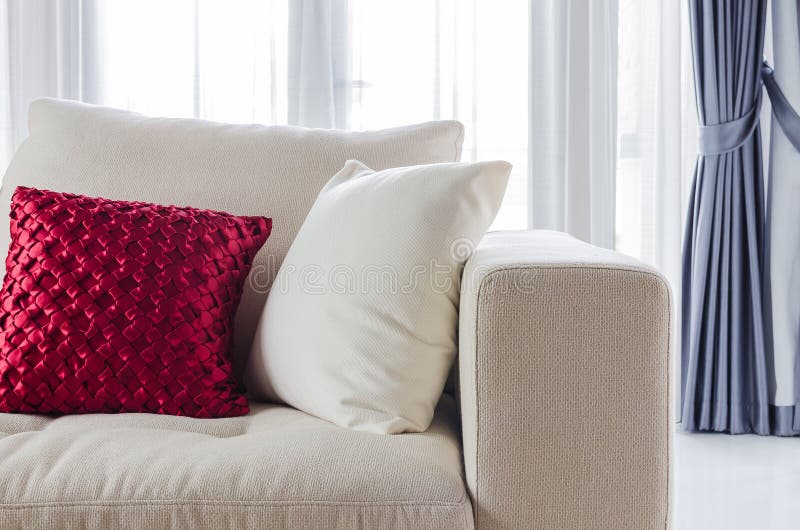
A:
[{"xmin": 0, "ymin": 187, "xmax": 272, "ymax": 418}]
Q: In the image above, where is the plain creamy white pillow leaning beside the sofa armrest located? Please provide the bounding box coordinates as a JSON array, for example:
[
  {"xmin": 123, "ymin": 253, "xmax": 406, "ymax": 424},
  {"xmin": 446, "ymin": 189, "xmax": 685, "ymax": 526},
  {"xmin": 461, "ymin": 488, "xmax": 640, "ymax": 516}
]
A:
[{"xmin": 246, "ymin": 161, "xmax": 511, "ymax": 434}]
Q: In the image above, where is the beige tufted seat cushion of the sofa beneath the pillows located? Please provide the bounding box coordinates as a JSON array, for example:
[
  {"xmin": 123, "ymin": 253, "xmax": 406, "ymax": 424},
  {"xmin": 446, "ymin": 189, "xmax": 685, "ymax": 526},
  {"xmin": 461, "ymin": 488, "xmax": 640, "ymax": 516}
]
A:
[{"xmin": 0, "ymin": 396, "xmax": 472, "ymax": 530}]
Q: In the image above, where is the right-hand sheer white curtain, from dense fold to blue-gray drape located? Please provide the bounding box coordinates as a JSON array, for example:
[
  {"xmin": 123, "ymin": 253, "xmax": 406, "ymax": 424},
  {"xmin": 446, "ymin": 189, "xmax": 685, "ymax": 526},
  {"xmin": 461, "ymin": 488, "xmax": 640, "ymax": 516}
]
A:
[{"xmin": 529, "ymin": 0, "xmax": 697, "ymax": 284}]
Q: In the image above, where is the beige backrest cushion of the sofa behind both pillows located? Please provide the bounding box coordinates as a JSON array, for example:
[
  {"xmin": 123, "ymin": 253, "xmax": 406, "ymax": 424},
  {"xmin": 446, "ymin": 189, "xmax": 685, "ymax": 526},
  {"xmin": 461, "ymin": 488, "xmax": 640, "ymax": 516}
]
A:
[{"xmin": 0, "ymin": 99, "xmax": 463, "ymax": 368}]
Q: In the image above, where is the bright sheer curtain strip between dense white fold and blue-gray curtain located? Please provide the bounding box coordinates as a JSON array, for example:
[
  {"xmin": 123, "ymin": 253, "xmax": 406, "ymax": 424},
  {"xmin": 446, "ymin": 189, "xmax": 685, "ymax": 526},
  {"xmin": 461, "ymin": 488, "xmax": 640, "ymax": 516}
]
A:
[{"xmin": 615, "ymin": 0, "xmax": 697, "ymax": 286}]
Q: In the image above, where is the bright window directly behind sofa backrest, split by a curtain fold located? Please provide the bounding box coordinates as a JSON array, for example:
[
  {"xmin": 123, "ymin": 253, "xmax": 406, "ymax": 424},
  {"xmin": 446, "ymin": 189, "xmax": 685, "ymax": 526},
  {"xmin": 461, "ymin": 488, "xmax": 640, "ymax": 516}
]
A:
[{"xmin": 95, "ymin": 0, "xmax": 528, "ymax": 229}]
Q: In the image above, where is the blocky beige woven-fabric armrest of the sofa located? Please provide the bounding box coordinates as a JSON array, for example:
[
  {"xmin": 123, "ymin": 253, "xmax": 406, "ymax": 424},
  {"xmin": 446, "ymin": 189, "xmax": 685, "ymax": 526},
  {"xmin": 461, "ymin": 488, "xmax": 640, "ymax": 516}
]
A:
[{"xmin": 458, "ymin": 231, "xmax": 671, "ymax": 530}]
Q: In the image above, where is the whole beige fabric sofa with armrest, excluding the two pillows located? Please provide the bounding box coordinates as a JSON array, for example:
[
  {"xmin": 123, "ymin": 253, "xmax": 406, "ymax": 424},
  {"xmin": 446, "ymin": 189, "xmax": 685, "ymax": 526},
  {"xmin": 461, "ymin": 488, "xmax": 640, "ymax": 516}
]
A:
[{"xmin": 0, "ymin": 101, "xmax": 670, "ymax": 530}]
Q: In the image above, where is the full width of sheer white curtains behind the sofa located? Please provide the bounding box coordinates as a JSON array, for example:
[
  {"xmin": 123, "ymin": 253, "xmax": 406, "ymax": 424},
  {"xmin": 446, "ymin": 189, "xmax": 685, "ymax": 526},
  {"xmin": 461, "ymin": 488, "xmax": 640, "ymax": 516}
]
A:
[{"xmin": 0, "ymin": 0, "xmax": 695, "ymax": 270}]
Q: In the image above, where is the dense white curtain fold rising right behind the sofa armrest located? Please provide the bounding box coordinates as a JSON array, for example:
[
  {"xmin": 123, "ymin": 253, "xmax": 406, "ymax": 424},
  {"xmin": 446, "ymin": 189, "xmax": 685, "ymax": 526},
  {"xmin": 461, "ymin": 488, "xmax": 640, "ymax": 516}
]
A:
[{"xmin": 528, "ymin": 0, "xmax": 619, "ymax": 248}]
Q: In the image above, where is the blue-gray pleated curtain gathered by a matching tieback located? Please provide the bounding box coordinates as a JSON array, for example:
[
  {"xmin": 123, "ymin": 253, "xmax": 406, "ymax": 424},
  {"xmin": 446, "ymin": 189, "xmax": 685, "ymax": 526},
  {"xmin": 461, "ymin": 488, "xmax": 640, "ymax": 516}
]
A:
[{"xmin": 680, "ymin": 0, "xmax": 773, "ymax": 434}]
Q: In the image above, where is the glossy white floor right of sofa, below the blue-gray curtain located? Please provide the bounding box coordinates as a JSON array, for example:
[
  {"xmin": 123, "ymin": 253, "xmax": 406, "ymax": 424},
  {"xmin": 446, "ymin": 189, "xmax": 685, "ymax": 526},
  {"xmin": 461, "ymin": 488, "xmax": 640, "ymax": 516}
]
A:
[{"xmin": 673, "ymin": 432, "xmax": 800, "ymax": 530}]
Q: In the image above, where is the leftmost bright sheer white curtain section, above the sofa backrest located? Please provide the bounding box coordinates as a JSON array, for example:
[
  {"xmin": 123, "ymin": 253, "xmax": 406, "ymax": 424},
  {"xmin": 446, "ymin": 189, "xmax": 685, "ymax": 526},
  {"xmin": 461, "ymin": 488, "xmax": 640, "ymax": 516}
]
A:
[{"xmin": 97, "ymin": 0, "xmax": 289, "ymax": 124}]
